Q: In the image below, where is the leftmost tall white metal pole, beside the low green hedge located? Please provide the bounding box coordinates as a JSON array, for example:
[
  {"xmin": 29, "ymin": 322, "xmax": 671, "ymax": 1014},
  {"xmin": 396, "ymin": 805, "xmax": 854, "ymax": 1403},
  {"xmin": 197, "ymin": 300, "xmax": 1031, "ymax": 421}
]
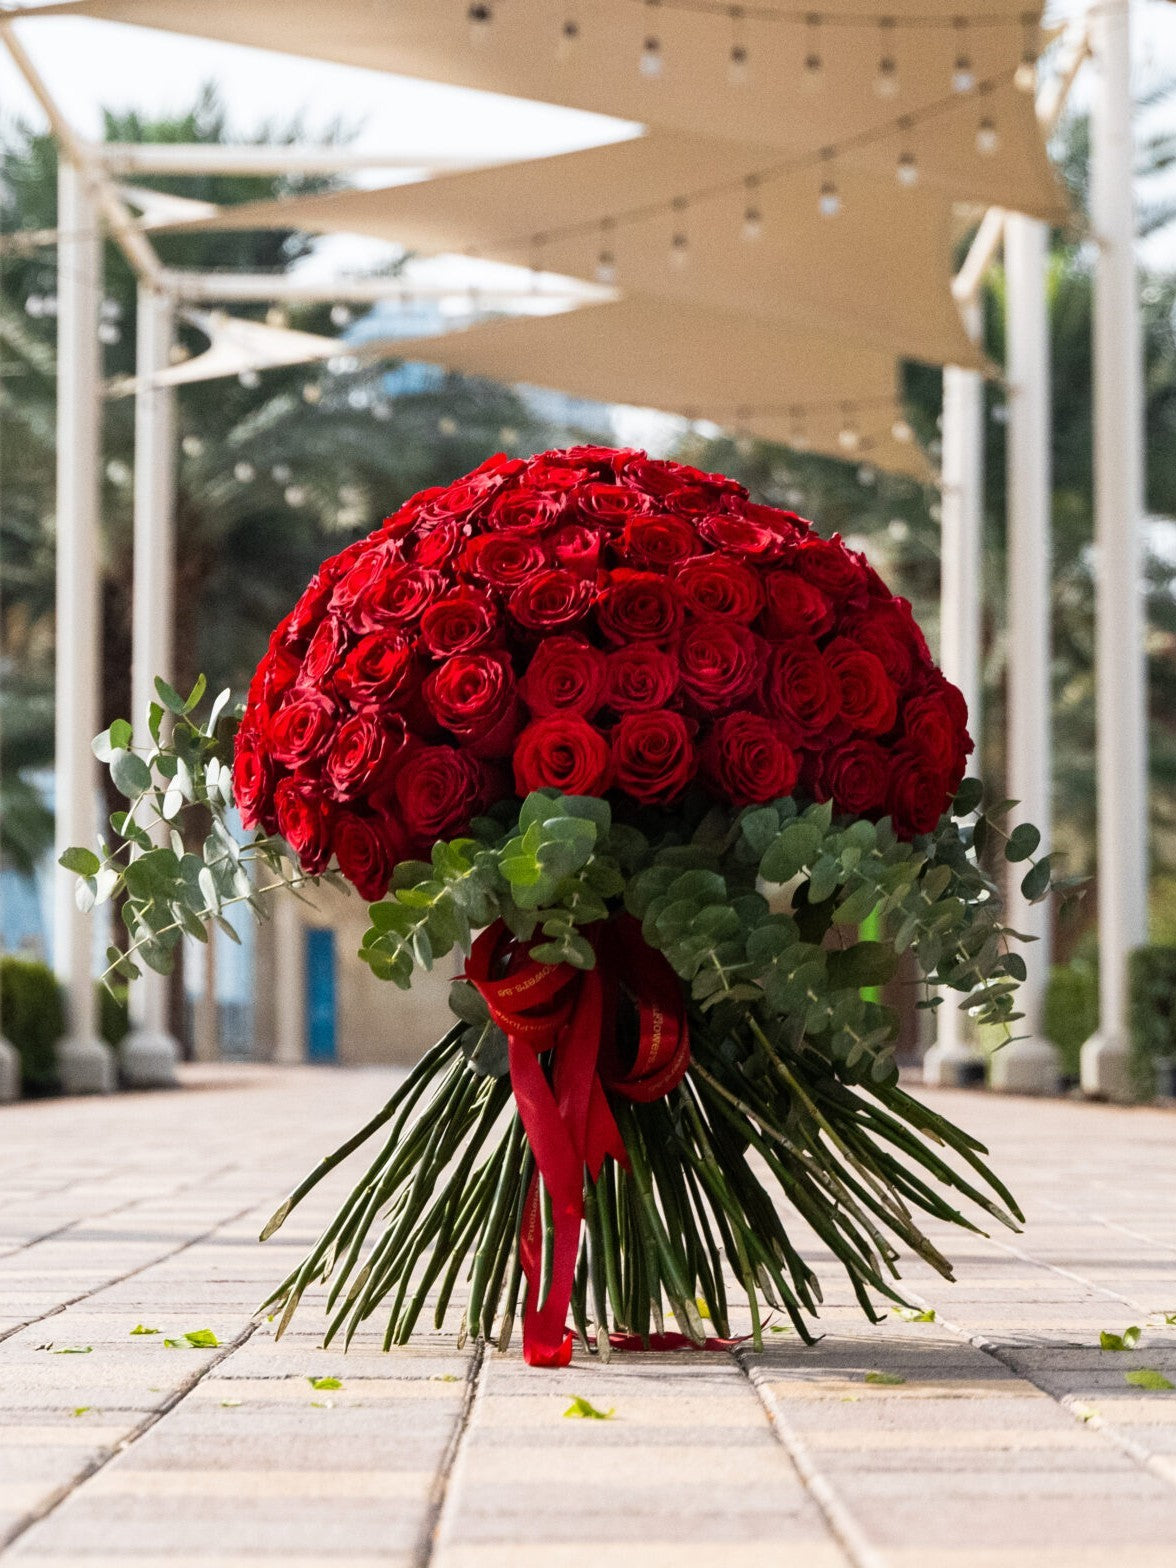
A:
[{"xmin": 53, "ymin": 157, "xmax": 114, "ymax": 1093}]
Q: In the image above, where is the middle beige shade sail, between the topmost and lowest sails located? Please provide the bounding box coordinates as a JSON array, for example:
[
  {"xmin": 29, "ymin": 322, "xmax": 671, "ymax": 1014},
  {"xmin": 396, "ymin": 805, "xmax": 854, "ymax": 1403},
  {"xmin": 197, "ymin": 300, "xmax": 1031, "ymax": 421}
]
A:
[{"xmin": 156, "ymin": 132, "xmax": 982, "ymax": 365}]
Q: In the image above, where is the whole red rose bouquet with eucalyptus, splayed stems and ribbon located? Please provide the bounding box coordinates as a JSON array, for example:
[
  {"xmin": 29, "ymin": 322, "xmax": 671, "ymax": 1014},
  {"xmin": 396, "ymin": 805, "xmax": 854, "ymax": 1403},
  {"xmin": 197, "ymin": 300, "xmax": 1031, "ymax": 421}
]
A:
[{"xmin": 62, "ymin": 447, "xmax": 1051, "ymax": 1364}]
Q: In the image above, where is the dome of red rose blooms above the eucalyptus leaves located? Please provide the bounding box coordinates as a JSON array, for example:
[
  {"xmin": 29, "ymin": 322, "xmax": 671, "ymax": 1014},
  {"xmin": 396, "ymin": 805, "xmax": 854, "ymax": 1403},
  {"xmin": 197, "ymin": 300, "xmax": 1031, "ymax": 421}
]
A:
[{"xmin": 234, "ymin": 447, "xmax": 972, "ymax": 898}]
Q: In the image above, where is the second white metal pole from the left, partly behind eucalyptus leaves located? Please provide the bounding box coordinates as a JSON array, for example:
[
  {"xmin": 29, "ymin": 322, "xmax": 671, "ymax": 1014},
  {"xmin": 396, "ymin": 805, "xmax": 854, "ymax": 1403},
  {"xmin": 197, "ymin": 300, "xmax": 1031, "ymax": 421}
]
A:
[{"xmin": 121, "ymin": 284, "xmax": 179, "ymax": 1088}]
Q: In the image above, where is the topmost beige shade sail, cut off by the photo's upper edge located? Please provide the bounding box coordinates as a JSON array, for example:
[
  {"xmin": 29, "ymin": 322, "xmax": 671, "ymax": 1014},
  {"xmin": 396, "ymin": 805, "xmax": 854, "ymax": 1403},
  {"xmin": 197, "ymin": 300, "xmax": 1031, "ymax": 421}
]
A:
[{"xmin": 53, "ymin": 0, "xmax": 1066, "ymax": 220}]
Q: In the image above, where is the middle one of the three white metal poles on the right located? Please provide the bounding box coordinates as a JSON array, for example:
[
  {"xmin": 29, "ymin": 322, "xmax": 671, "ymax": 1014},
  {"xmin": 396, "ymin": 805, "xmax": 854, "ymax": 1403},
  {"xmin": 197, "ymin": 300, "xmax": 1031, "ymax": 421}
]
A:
[{"xmin": 993, "ymin": 213, "xmax": 1062, "ymax": 1094}]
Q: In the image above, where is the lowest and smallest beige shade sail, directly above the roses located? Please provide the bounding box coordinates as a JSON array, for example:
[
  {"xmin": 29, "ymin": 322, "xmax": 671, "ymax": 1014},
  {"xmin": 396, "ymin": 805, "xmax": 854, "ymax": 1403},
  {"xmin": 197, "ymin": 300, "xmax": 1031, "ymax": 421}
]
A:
[{"xmin": 361, "ymin": 296, "xmax": 933, "ymax": 481}]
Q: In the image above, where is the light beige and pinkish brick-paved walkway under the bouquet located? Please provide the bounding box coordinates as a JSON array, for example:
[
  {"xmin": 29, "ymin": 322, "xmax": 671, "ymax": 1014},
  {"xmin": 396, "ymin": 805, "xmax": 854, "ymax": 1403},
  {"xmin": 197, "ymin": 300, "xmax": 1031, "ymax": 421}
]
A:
[{"xmin": 0, "ymin": 1069, "xmax": 1176, "ymax": 1568}]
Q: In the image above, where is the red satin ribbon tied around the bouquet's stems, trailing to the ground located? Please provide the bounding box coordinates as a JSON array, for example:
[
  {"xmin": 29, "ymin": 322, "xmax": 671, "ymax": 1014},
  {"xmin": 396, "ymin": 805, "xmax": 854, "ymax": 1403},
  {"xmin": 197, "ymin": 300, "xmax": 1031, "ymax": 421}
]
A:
[{"xmin": 466, "ymin": 914, "xmax": 690, "ymax": 1367}]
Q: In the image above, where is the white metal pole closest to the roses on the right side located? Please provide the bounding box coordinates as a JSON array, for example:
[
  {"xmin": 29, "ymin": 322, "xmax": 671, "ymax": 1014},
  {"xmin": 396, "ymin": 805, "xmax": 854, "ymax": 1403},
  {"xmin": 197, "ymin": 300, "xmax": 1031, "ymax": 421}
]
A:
[{"xmin": 924, "ymin": 299, "xmax": 985, "ymax": 1087}]
